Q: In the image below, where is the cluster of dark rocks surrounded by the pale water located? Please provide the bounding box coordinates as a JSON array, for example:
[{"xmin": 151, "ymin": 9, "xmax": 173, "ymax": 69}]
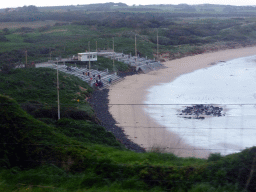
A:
[{"xmin": 178, "ymin": 104, "xmax": 224, "ymax": 119}]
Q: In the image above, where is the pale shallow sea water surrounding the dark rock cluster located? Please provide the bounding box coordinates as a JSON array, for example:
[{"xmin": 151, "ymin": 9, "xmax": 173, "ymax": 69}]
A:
[{"xmin": 145, "ymin": 55, "xmax": 256, "ymax": 155}]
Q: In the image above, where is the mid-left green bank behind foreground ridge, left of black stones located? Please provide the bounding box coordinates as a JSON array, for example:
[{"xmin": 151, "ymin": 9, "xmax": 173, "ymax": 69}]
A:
[{"xmin": 0, "ymin": 68, "xmax": 93, "ymax": 116}]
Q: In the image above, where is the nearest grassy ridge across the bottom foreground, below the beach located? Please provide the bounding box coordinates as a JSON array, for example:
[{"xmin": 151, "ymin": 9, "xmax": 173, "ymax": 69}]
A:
[{"xmin": 0, "ymin": 96, "xmax": 252, "ymax": 191}]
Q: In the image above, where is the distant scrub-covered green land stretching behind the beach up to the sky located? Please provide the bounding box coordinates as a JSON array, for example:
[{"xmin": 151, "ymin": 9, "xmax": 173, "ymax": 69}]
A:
[{"xmin": 0, "ymin": 3, "xmax": 256, "ymax": 70}]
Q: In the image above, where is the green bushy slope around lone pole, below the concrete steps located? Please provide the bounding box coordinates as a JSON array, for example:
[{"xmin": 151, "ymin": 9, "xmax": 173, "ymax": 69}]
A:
[{"xmin": 0, "ymin": 68, "xmax": 97, "ymax": 122}]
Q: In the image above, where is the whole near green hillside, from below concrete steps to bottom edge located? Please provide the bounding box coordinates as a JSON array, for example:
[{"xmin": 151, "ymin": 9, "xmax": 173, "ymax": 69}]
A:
[{"xmin": 0, "ymin": 68, "xmax": 256, "ymax": 192}]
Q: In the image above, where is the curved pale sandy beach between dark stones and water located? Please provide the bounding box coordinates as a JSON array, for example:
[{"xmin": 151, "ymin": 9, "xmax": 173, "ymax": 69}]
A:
[{"xmin": 109, "ymin": 47, "xmax": 256, "ymax": 158}]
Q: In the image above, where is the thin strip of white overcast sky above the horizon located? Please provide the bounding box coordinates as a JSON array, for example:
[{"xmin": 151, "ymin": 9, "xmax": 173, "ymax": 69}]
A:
[{"xmin": 0, "ymin": 0, "xmax": 256, "ymax": 8}]
